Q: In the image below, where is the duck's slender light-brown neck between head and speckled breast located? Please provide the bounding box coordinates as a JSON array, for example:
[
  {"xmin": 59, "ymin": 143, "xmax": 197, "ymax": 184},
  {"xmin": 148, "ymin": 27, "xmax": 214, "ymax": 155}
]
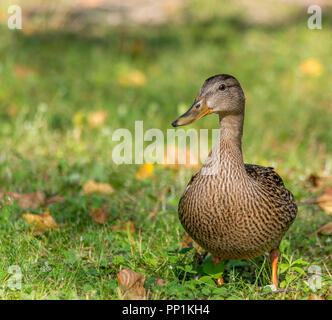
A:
[{"xmin": 203, "ymin": 114, "xmax": 245, "ymax": 176}]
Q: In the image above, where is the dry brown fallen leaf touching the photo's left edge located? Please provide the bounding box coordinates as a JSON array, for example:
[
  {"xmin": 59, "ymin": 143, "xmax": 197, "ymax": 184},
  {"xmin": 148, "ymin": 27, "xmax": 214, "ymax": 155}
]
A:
[{"xmin": 0, "ymin": 191, "xmax": 45, "ymax": 209}]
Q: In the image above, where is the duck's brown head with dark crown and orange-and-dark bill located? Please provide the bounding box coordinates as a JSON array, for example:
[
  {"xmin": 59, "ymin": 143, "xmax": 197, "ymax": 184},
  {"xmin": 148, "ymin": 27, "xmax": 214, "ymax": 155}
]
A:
[{"xmin": 172, "ymin": 74, "xmax": 245, "ymax": 127}]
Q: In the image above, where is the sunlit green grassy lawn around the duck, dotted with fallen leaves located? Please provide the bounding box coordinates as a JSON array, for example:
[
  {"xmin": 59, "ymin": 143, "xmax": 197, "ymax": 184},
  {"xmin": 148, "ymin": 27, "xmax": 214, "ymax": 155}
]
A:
[{"xmin": 0, "ymin": 2, "xmax": 332, "ymax": 299}]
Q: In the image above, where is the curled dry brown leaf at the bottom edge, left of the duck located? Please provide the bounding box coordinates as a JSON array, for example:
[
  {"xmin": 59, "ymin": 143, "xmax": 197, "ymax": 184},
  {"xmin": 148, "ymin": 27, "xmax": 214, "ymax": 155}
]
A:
[{"xmin": 117, "ymin": 269, "xmax": 146, "ymax": 300}]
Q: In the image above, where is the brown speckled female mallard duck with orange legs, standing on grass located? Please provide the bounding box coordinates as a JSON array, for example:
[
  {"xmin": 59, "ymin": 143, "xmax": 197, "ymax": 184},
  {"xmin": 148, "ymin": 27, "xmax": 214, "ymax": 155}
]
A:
[{"xmin": 172, "ymin": 74, "xmax": 297, "ymax": 286}]
